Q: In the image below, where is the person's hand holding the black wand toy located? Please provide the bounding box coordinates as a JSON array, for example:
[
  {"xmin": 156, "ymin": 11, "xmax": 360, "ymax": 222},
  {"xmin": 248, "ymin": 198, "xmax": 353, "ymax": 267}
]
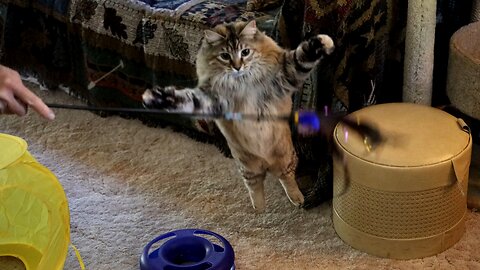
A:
[{"xmin": 0, "ymin": 65, "xmax": 55, "ymax": 120}]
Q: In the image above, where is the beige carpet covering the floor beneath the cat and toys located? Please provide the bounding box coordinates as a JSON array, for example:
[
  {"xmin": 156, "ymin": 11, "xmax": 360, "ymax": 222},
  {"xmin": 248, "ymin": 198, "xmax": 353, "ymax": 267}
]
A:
[{"xmin": 0, "ymin": 83, "xmax": 480, "ymax": 270}]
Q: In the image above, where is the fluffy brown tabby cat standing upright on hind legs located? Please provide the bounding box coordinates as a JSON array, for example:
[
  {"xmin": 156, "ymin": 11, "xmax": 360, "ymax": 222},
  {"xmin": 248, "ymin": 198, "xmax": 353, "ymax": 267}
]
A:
[{"xmin": 142, "ymin": 21, "xmax": 334, "ymax": 211}]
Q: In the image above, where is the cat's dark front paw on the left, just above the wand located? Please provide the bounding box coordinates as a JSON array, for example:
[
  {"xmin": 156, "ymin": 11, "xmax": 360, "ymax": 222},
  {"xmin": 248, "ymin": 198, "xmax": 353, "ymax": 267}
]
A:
[{"xmin": 142, "ymin": 85, "xmax": 181, "ymax": 110}]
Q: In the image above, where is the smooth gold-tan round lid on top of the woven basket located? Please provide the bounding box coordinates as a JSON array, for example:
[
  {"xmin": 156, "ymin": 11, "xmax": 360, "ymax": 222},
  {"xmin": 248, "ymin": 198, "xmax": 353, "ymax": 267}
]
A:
[{"xmin": 334, "ymin": 103, "xmax": 470, "ymax": 167}]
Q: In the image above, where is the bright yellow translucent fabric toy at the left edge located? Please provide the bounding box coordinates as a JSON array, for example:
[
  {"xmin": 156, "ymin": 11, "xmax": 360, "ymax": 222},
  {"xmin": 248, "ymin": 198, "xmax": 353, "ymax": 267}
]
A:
[{"xmin": 0, "ymin": 134, "xmax": 70, "ymax": 270}]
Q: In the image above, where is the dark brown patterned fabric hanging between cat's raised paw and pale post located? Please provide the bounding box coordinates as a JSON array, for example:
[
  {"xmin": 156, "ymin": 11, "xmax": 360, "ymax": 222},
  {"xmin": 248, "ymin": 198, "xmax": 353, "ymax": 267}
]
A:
[{"xmin": 279, "ymin": 0, "xmax": 406, "ymax": 111}]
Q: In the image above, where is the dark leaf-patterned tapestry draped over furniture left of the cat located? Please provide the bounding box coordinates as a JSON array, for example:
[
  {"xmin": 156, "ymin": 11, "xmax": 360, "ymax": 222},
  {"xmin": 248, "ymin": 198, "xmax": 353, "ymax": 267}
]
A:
[{"xmin": 0, "ymin": 0, "xmax": 275, "ymax": 107}]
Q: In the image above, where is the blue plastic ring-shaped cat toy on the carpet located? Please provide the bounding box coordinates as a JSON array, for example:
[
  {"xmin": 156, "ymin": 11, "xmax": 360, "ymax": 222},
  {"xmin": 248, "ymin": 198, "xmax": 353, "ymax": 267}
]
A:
[{"xmin": 140, "ymin": 229, "xmax": 235, "ymax": 270}]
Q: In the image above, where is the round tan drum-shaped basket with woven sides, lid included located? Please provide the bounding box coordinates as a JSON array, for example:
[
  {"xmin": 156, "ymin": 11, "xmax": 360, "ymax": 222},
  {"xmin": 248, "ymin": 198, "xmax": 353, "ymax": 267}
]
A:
[{"xmin": 333, "ymin": 103, "xmax": 472, "ymax": 259}]
